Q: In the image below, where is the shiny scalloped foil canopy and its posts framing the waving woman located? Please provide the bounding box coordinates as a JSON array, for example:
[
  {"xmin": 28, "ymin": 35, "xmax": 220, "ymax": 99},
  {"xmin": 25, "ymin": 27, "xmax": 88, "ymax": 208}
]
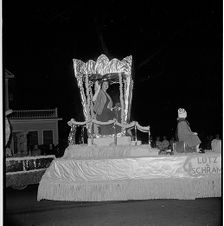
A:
[{"xmin": 73, "ymin": 54, "xmax": 133, "ymax": 132}]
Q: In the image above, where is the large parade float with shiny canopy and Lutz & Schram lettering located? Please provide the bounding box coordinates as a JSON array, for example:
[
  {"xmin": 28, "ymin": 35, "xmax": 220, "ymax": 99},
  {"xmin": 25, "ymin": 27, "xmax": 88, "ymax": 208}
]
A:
[{"xmin": 37, "ymin": 55, "xmax": 221, "ymax": 201}]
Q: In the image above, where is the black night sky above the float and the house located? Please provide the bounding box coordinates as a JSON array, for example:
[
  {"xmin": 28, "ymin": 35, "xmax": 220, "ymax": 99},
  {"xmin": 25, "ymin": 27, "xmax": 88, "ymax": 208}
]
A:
[{"xmin": 3, "ymin": 0, "xmax": 223, "ymax": 140}]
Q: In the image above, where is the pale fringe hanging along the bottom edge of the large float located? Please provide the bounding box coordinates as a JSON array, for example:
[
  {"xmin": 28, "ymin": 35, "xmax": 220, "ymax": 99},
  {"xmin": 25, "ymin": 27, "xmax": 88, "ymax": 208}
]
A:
[{"xmin": 37, "ymin": 177, "xmax": 221, "ymax": 201}]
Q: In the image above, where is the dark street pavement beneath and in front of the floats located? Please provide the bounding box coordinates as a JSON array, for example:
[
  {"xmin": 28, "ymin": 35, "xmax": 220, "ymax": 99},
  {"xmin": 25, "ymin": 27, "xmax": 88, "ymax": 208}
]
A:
[{"xmin": 4, "ymin": 185, "xmax": 222, "ymax": 226}]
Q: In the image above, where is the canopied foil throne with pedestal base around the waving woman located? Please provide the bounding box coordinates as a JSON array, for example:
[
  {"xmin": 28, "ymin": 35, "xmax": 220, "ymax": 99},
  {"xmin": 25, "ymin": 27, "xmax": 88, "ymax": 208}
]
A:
[{"xmin": 68, "ymin": 54, "xmax": 149, "ymax": 145}]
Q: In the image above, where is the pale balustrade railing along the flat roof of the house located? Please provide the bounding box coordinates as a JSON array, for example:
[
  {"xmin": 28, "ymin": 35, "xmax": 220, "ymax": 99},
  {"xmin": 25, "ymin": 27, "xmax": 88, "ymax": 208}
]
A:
[{"xmin": 9, "ymin": 108, "xmax": 58, "ymax": 119}]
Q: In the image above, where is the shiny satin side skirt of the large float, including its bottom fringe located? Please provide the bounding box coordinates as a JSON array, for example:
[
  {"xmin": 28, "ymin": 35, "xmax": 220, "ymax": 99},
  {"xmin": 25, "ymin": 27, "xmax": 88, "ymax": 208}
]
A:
[{"xmin": 37, "ymin": 153, "xmax": 221, "ymax": 201}]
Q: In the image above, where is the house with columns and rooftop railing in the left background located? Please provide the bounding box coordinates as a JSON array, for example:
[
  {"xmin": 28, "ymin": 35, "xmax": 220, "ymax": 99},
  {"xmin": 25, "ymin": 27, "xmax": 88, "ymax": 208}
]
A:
[{"xmin": 4, "ymin": 70, "xmax": 62, "ymax": 156}]
